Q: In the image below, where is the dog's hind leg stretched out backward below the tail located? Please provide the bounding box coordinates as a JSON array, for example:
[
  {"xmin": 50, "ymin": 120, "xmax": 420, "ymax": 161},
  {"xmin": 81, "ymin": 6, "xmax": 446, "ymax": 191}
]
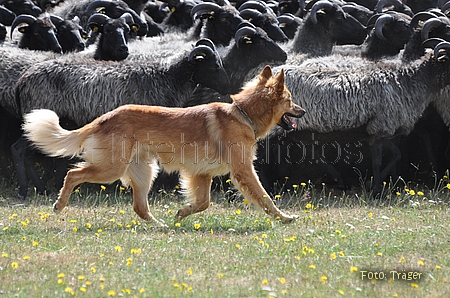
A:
[{"xmin": 53, "ymin": 163, "xmax": 126, "ymax": 213}]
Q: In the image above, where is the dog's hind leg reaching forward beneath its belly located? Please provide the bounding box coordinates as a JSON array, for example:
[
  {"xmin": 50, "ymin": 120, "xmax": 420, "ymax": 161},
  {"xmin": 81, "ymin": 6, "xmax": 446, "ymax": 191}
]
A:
[{"xmin": 121, "ymin": 162, "xmax": 165, "ymax": 226}]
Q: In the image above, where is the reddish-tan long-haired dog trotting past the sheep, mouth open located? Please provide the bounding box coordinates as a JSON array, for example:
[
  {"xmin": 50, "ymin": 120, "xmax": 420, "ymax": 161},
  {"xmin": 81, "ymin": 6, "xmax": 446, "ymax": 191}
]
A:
[{"xmin": 23, "ymin": 66, "xmax": 305, "ymax": 224}]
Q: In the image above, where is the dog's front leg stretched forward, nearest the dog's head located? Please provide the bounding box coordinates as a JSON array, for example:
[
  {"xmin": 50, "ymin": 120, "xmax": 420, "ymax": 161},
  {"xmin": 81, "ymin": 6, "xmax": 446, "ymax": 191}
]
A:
[{"xmin": 231, "ymin": 164, "xmax": 297, "ymax": 223}]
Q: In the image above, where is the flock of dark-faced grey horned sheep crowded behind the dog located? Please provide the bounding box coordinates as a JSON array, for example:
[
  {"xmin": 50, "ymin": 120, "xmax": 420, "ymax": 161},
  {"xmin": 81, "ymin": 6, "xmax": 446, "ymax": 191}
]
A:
[{"xmin": 0, "ymin": 0, "xmax": 450, "ymax": 198}]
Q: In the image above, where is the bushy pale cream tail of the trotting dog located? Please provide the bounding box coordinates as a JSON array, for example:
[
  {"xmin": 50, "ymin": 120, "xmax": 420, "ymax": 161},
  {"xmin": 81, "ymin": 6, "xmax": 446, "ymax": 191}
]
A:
[{"xmin": 22, "ymin": 109, "xmax": 85, "ymax": 157}]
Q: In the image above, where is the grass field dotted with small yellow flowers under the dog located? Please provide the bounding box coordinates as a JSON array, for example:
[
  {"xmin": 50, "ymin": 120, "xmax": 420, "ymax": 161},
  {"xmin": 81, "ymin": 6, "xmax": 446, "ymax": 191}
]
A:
[{"xmin": 0, "ymin": 176, "xmax": 450, "ymax": 297}]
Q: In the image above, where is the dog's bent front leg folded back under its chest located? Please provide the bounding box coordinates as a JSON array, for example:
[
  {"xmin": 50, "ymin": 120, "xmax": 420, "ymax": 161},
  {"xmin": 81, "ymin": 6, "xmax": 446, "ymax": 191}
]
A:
[{"xmin": 176, "ymin": 174, "xmax": 212, "ymax": 219}]
